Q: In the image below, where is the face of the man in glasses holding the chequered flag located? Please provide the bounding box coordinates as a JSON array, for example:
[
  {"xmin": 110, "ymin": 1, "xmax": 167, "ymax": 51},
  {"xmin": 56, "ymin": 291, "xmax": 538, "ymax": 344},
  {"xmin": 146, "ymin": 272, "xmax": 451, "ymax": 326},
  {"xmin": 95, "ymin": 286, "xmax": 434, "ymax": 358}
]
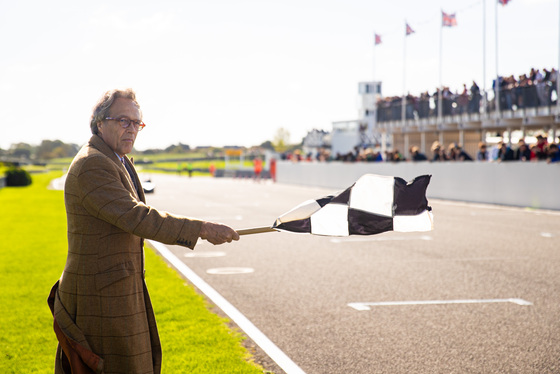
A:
[{"xmin": 97, "ymin": 98, "xmax": 142, "ymax": 157}]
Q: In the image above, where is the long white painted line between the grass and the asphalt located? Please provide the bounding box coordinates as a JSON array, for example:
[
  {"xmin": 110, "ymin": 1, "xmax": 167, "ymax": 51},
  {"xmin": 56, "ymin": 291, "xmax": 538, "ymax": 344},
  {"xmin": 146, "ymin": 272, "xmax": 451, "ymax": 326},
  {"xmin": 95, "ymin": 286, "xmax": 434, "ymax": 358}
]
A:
[{"xmin": 147, "ymin": 240, "xmax": 305, "ymax": 374}]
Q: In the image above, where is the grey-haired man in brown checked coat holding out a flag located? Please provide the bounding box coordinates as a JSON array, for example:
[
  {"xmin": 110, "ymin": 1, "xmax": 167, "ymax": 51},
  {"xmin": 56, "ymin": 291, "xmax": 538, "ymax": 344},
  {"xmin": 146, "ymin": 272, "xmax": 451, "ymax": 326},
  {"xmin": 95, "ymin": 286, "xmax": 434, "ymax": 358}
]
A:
[{"xmin": 49, "ymin": 90, "xmax": 239, "ymax": 374}]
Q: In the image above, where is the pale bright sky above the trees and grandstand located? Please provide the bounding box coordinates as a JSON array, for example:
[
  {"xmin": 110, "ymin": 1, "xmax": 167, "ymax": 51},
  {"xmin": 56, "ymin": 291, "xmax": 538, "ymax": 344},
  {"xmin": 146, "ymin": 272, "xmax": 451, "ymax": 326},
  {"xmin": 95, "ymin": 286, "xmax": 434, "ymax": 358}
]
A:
[{"xmin": 0, "ymin": 0, "xmax": 560, "ymax": 150}]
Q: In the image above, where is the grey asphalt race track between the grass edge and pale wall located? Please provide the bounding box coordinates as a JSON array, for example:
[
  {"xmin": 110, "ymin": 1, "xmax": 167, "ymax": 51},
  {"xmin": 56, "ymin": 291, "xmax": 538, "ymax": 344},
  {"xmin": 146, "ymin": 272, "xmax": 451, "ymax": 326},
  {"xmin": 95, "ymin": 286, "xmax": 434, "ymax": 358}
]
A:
[{"xmin": 142, "ymin": 175, "xmax": 560, "ymax": 374}]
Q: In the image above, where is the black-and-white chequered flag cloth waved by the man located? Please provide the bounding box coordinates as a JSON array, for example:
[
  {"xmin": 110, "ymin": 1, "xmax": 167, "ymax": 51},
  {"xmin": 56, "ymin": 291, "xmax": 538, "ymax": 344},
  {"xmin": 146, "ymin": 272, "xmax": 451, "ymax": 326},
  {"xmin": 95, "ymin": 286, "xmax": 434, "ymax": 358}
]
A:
[{"xmin": 272, "ymin": 174, "xmax": 433, "ymax": 236}]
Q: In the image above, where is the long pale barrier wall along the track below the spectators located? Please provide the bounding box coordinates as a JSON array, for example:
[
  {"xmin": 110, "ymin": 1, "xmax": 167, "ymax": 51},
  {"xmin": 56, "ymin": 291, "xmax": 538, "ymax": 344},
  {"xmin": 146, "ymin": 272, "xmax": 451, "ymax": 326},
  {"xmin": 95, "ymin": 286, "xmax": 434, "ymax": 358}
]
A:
[{"xmin": 276, "ymin": 161, "xmax": 560, "ymax": 210}]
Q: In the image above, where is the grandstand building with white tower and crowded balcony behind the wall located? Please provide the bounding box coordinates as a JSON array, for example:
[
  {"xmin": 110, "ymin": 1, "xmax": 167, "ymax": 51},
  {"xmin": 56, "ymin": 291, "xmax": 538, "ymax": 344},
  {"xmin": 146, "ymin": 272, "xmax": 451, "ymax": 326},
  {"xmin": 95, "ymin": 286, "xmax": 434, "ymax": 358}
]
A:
[{"xmin": 332, "ymin": 82, "xmax": 560, "ymax": 158}]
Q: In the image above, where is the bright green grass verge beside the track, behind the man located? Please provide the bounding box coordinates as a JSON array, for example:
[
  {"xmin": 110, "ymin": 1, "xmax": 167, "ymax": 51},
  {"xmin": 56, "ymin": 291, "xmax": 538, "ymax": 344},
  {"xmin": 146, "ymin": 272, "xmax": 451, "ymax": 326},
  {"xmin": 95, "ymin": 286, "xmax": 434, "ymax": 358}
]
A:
[{"xmin": 0, "ymin": 172, "xmax": 270, "ymax": 374}]
